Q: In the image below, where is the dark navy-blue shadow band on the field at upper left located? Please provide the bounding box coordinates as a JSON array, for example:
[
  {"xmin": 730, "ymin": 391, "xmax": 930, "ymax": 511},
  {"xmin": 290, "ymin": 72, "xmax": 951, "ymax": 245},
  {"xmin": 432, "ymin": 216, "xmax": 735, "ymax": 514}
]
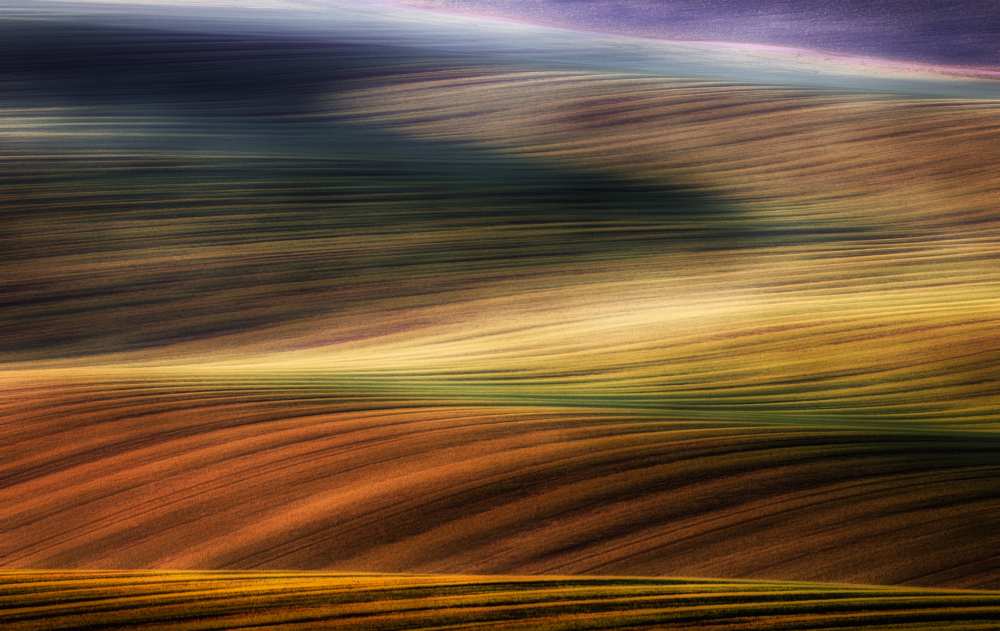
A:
[{"xmin": 0, "ymin": 19, "xmax": 450, "ymax": 116}]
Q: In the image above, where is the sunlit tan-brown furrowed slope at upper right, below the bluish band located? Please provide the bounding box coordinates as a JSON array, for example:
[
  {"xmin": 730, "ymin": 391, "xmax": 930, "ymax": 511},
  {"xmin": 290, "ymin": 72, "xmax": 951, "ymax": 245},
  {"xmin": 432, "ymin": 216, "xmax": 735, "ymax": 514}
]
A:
[{"xmin": 343, "ymin": 71, "xmax": 1000, "ymax": 230}]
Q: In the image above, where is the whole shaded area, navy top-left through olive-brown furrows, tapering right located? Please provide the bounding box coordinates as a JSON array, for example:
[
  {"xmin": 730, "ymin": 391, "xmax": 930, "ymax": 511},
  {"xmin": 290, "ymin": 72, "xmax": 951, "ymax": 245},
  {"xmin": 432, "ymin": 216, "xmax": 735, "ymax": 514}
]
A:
[{"xmin": 0, "ymin": 22, "xmax": 856, "ymax": 360}]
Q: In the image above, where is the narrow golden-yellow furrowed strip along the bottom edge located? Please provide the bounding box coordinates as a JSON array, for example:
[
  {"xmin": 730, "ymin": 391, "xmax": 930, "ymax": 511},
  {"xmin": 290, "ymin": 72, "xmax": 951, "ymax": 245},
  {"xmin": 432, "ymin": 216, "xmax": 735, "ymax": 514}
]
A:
[{"xmin": 0, "ymin": 571, "xmax": 1000, "ymax": 631}]
